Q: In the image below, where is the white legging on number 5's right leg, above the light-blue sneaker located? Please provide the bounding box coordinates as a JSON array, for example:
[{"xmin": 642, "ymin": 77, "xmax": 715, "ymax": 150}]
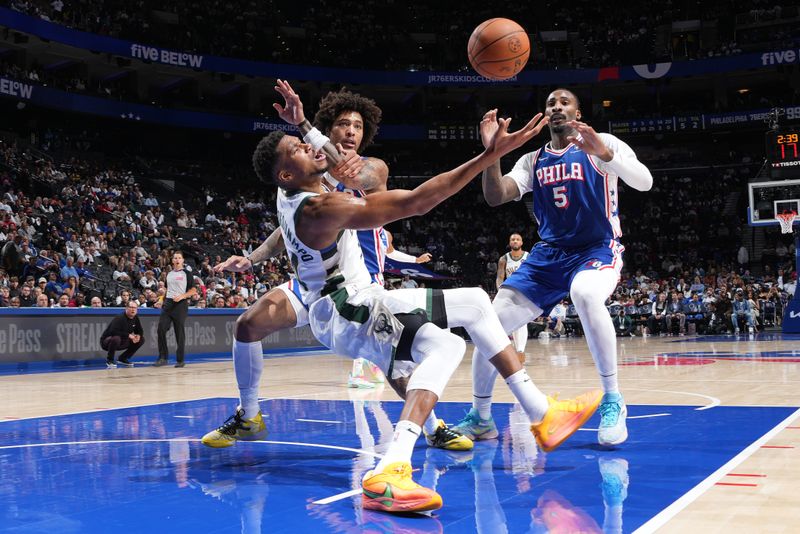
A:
[{"xmin": 570, "ymin": 269, "xmax": 619, "ymax": 393}]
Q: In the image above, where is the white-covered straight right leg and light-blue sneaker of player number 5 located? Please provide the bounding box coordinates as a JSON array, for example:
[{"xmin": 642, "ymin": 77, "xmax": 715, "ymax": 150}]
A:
[{"xmin": 570, "ymin": 269, "xmax": 628, "ymax": 445}]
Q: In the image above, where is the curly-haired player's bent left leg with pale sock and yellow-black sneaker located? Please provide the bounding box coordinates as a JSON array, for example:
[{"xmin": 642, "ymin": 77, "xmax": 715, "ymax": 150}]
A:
[{"xmin": 202, "ymin": 282, "xmax": 308, "ymax": 448}]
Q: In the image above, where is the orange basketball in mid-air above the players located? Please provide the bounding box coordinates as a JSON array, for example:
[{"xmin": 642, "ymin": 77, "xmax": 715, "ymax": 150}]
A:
[{"xmin": 467, "ymin": 18, "xmax": 531, "ymax": 80}]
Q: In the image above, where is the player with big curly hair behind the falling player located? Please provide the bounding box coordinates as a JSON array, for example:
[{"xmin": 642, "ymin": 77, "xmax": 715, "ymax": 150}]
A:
[{"xmin": 202, "ymin": 90, "xmax": 468, "ymax": 450}]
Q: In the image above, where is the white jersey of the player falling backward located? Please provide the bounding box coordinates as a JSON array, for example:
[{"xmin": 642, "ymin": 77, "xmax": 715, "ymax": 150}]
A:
[{"xmin": 277, "ymin": 188, "xmax": 372, "ymax": 306}]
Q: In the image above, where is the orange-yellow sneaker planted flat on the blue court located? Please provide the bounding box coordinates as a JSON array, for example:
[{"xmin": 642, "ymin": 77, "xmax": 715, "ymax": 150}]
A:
[{"xmin": 361, "ymin": 462, "xmax": 442, "ymax": 512}]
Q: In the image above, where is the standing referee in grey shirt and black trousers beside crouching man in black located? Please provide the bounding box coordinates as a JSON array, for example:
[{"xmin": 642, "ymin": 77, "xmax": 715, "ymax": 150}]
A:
[{"xmin": 155, "ymin": 251, "xmax": 197, "ymax": 367}]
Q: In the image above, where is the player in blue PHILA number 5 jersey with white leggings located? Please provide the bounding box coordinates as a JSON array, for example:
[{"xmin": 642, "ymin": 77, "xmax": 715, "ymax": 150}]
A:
[{"xmin": 455, "ymin": 89, "xmax": 653, "ymax": 445}]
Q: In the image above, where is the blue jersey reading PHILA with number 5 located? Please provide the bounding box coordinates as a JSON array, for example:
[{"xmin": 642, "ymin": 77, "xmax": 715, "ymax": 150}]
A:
[{"xmin": 509, "ymin": 134, "xmax": 624, "ymax": 248}]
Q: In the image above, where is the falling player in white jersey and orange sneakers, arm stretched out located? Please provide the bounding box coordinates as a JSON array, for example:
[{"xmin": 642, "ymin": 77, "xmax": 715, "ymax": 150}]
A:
[{"xmin": 253, "ymin": 80, "xmax": 600, "ymax": 512}]
